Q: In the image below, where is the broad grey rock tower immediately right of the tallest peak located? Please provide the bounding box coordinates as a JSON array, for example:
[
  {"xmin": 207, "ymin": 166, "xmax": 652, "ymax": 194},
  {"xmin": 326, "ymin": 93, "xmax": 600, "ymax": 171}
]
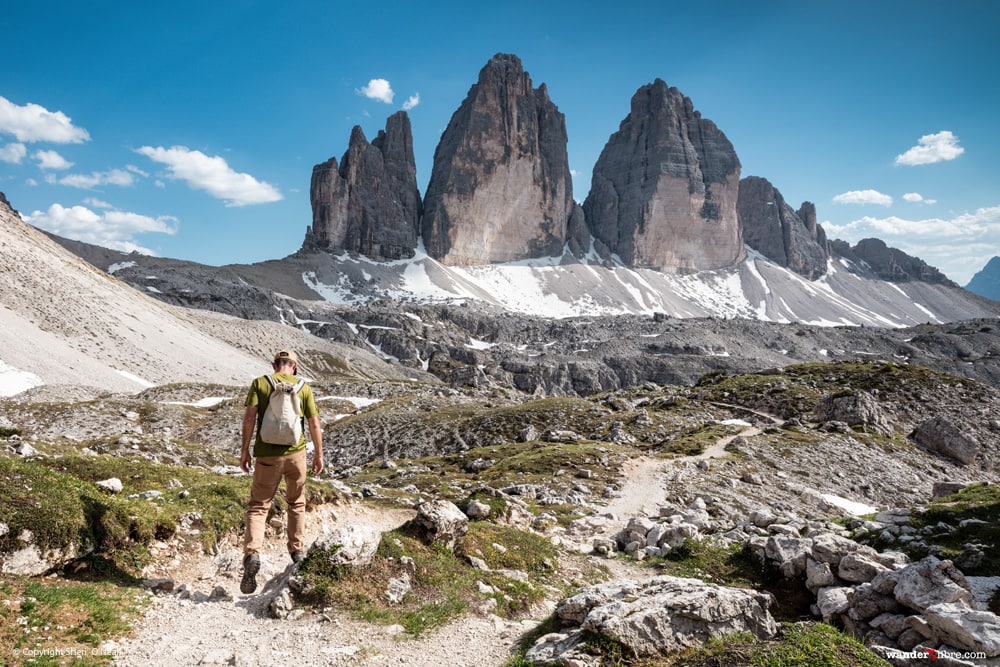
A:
[{"xmin": 583, "ymin": 79, "xmax": 745, "ymax": 273}]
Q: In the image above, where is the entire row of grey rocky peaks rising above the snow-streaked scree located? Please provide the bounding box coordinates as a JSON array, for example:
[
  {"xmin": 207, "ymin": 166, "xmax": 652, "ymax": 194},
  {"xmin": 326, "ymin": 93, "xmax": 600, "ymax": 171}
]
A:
[{"xmin": 303, "ymin": 54, "xmax": 947, "ymax": 282}]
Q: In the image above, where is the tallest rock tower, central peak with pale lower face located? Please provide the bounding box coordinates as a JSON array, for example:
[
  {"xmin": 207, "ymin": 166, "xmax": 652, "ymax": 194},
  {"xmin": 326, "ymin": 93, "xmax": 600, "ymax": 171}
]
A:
[{"xmin": 421, "ymin": 54, "xmax": 574, "ymax": 265}]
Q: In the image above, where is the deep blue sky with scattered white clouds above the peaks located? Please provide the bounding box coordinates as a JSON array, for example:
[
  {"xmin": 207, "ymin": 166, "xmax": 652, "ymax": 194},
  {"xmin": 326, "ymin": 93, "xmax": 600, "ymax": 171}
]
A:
[{"xmin": 0, "ymin": 0, "xmax": 1000, "ymax": 284}]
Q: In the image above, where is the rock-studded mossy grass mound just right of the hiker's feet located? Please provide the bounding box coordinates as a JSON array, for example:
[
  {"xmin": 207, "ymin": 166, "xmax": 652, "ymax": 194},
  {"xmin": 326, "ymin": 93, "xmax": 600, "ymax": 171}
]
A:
[{"xmin": 298, "ymin": 522, "xmax": 559, "ymax": 637}]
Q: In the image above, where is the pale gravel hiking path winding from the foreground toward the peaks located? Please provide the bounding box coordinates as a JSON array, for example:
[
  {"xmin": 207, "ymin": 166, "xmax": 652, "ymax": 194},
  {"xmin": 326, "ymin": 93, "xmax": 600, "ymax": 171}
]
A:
[{"xmin": 114, "ymin": 428, "xmax": 756, "ymax": 667}]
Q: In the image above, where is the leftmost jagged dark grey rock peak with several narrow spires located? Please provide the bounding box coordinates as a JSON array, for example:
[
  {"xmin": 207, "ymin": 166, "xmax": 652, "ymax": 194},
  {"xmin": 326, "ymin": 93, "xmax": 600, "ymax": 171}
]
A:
[{"xmin": 304, "ymin": 111, "xmax": 422, "ymax": 259}]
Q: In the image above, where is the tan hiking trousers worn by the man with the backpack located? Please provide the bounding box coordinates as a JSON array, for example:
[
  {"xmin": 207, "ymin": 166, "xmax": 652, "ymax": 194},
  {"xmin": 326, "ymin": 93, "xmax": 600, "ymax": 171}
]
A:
[{"xmin": 243, "ymin": 449, "xmax": 306, "ymax": 554}]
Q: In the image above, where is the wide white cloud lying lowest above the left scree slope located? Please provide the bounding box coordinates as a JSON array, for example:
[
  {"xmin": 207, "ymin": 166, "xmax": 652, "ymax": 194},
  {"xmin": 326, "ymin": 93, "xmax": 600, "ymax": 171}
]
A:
[{"xmin": 23, "ymin": 202, "xmax": 177, "ymax": 255}]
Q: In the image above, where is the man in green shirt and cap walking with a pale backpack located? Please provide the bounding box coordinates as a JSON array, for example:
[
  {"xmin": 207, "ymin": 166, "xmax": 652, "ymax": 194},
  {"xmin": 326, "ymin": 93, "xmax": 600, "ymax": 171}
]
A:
[{"xmin": 240, "ymin": 350, "xmax": 323, "ymax": 594}]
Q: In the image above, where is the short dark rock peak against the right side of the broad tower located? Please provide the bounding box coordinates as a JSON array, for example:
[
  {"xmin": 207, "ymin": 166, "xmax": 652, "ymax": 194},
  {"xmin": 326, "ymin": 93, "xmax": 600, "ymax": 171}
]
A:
[{"xmin": 736, "ymin": 176, "xmax": 830, "ymax": 280}]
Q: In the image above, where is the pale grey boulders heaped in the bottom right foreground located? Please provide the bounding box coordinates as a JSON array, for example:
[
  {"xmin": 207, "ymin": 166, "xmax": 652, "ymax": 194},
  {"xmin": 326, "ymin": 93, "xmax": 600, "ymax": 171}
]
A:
[{"xmin": 552, "ymin": 498, "xmax": 1000, "ymax": 664}]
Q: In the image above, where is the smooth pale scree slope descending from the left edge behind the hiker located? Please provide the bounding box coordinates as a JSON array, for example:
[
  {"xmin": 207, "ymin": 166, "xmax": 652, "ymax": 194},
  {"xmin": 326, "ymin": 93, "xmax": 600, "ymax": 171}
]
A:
[{"xmin": 0, "ymin": 193, "xmax": 438, "ymax": 394}]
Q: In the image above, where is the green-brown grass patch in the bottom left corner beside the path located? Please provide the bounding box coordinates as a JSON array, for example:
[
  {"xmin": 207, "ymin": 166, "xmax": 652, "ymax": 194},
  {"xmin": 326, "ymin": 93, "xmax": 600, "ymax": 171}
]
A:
[{"xmin": 0, "ymin": 578, "xmax": 148, "ymax": 667}]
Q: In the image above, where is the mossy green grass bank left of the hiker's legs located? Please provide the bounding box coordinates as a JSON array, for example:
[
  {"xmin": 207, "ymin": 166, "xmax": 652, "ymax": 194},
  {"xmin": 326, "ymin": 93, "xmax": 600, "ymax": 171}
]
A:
[{"xmin": 0, "ymin": 455, "xmax": 337, "ymax": 580}]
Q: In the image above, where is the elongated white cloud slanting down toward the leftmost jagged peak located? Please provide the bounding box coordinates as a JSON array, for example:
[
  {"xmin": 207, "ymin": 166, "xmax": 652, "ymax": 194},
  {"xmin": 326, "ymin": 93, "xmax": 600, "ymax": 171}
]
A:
[{"xmin": 136, "ymin": 146, "xmax": 283, "ymax": 206}]
